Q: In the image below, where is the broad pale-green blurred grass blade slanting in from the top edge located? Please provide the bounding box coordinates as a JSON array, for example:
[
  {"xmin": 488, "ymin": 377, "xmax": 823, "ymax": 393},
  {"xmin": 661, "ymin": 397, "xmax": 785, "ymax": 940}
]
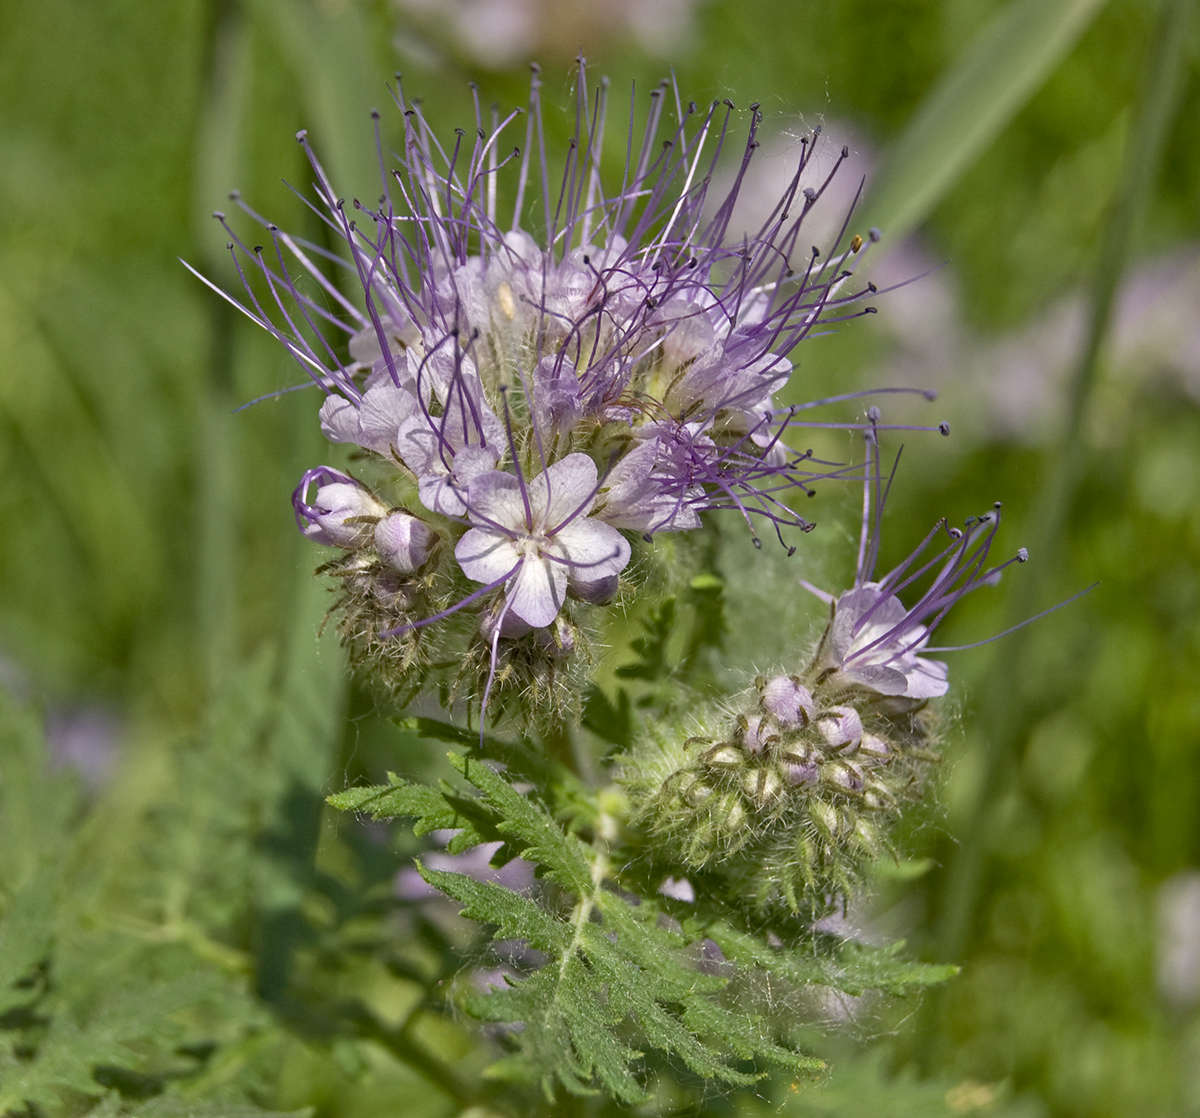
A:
[{"xmin": 856, "ymin": 0, "xmax": 1105, "ymax": 240}]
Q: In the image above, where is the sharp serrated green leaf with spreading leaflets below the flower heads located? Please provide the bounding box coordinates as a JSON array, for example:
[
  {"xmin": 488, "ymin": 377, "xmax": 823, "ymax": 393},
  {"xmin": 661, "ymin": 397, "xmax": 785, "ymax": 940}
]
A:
[{"xmin": 329, "ymin": 753, "xmax": 955, "ymax": 1102}]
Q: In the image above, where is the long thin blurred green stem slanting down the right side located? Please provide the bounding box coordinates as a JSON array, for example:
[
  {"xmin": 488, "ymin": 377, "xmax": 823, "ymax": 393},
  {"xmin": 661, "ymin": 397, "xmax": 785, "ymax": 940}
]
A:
[{"xmin": 926, "ymin": 0, "xmax": 1193, "ymax": 998}]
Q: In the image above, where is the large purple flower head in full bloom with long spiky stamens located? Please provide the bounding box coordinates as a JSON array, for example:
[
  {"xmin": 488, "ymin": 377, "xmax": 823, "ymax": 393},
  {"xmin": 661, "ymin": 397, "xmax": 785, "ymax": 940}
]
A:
[{"xmin": 194, "ymin": 65, "xmax": 902, "ymax": 701}]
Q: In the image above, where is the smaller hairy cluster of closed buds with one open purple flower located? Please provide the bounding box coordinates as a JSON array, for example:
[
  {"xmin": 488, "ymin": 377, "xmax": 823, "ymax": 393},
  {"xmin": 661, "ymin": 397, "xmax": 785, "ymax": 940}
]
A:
[{"xmin": 624, "ymin": 431, "xmax": 1027, "ymax": 914}]
